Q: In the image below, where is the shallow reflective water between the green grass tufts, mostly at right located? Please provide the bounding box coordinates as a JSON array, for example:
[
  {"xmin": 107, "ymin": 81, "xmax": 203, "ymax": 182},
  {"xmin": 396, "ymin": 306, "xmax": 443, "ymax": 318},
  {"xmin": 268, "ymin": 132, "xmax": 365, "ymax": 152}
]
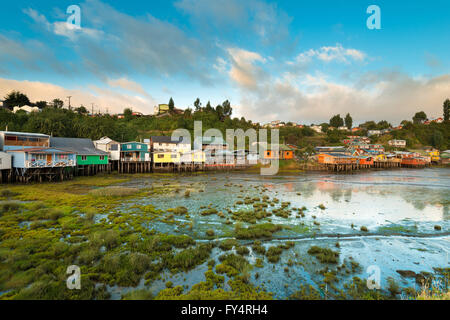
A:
[{"xmin": 112, "ymin": 168, "xmax": 450, "ymax": 299}]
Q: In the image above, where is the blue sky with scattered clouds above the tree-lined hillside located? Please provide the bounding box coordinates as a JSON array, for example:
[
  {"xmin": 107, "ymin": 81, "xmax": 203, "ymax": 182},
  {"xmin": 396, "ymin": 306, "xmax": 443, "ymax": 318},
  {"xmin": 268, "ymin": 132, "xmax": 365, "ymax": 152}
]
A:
[{"xmin": 0, "ymin": 0, "xmax": 450, "ymax": 124}]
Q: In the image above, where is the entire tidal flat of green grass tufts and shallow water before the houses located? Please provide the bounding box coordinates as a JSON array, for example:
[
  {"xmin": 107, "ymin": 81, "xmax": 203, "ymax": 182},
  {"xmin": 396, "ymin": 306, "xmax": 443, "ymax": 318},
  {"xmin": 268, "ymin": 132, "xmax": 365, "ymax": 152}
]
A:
[{"xmin": 0, "ymin": 168, "xmax": 450, "ymax": 299}]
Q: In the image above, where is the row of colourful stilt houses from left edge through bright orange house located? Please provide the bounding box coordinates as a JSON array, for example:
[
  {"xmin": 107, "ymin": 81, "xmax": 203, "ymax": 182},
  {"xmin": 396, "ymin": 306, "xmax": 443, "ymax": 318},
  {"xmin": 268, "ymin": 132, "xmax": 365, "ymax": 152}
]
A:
[{"xmin": 0, "ymin": 131, "xmax": 294, "ymax": 182}]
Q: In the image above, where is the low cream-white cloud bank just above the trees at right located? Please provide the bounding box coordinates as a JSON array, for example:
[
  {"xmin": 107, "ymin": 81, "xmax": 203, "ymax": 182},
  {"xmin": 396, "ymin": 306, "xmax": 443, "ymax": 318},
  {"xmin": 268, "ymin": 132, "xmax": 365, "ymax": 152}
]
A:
[{"xmin": 240, "ymin": 74, "xmax": 450, "ymax": 123}]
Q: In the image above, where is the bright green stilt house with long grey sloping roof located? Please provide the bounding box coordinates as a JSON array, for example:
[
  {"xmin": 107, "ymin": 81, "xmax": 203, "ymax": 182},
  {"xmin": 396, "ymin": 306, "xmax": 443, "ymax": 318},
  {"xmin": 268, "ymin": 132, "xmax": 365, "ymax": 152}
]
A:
[{"xmin": 50, "ymin": 137, "xmax": 109, "ymax": 175}]
